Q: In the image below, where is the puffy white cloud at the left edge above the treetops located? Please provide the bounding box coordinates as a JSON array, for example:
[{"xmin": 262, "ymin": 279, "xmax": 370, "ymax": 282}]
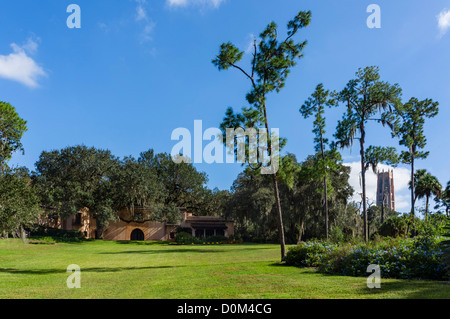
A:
[{"xmin": 0, "ymin": 39, "xmax": 47, "ymax": 88}]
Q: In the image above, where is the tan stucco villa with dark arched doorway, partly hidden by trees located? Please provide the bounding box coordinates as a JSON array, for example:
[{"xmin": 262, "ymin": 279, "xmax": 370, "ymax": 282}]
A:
[{"xmin": 47, "ymin": 207, "xmax": 234, "ymax": 241}]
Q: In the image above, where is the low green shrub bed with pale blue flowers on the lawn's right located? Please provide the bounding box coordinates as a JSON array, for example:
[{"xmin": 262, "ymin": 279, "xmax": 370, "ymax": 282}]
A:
[{"xmin": 286, "ymin": 237, "xmax": 446, "ymax": 280}]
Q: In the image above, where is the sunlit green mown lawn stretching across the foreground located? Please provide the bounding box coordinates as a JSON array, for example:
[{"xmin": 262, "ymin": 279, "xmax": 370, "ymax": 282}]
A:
[{"xmin": 0, "ymin": 239, "xmax": 450, "ymax": 299}]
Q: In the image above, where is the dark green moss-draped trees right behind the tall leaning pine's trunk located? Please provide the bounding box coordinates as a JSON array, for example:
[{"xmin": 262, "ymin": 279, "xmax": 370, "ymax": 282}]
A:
[{"xmin": 224, "ymin": 153, "xmax": 360, "ymax": 244}]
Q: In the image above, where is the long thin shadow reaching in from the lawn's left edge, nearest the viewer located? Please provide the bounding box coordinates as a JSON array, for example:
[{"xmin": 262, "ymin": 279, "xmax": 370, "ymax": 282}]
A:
[{"xmin": 0, "ymin": 266, "xmax": 179, "ymax": 275}]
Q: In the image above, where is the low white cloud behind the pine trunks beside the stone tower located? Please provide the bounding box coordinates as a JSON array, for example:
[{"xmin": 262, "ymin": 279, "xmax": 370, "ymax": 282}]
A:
[{"xmin": 344, "ymin": 162, "xmax": 411, "ymax": 212}]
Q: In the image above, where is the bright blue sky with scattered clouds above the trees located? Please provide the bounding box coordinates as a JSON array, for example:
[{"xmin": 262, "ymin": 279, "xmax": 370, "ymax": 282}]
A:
[{"xmin": 0, "ymin": 0, "xmax": 450, "ymax": 215}]
